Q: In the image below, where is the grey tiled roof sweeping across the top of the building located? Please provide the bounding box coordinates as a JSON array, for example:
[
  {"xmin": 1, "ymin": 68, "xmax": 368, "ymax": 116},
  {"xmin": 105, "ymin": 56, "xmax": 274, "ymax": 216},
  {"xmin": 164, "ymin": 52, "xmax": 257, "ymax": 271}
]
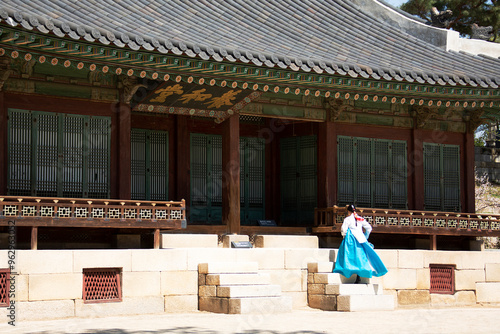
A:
[{"xmin": 0, "ymin": 0, "xmax": 500, "ymax": 88}]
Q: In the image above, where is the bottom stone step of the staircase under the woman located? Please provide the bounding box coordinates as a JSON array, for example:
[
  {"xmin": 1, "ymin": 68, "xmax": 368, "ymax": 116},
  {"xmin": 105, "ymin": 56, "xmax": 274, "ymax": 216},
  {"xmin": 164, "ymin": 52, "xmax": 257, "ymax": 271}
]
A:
[{"xmin": 337, "ymin": 295, "xmax": 394, "ymax": 312}]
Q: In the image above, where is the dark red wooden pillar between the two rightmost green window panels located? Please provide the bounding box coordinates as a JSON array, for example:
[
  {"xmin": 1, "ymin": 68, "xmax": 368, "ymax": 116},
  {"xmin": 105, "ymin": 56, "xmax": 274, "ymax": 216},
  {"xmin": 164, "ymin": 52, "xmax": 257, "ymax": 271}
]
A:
[{"xmin": 408, "ymin": 129, "xmax": 425, "ymax": 210}]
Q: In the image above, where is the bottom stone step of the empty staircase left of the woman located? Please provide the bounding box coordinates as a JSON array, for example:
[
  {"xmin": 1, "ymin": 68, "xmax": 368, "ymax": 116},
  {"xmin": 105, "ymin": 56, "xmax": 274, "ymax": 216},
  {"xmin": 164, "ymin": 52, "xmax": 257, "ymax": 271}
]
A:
[{"xmin": 199, "ymin": 296, "xmax": 292, "ymax": 314}]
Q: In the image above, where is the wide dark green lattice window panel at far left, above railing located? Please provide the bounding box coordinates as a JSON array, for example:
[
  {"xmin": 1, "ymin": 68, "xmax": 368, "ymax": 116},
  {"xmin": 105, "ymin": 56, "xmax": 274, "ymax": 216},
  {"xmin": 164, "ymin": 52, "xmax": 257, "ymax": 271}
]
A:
[{"xmin": 7, "ymin": 109, "xmax": 111, "ymax": 198}]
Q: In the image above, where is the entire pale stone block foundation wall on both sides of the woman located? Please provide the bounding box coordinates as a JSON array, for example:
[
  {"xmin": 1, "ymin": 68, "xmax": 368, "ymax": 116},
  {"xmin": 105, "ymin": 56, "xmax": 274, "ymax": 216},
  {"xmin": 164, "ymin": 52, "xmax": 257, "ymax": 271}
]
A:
[{"xmin": 0, "ymin": 248, "xmax": 500, "ymax": 321}]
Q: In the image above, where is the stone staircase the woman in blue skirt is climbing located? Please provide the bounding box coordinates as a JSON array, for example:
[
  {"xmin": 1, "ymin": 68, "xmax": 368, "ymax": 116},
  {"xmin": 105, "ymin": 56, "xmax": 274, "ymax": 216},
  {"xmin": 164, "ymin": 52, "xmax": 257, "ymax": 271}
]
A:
[{"xmin": 307, "ymin": 262, "xmax": 394, "ymax": 312}]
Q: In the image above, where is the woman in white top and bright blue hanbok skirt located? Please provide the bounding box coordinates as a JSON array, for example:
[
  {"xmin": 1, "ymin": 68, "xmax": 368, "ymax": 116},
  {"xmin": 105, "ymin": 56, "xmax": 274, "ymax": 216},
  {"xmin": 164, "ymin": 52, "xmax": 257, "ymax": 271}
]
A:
[{"xmin": 333, "ymin": 204, "xmax": 387, "ymax": 283}]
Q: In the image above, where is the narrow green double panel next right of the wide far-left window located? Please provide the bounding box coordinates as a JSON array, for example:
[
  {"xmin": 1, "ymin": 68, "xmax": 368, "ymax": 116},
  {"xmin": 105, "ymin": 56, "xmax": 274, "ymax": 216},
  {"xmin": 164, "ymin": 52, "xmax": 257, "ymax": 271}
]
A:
[{"xmin": 130, "ymin": 129, "xmax": 168, "ymax": 201}]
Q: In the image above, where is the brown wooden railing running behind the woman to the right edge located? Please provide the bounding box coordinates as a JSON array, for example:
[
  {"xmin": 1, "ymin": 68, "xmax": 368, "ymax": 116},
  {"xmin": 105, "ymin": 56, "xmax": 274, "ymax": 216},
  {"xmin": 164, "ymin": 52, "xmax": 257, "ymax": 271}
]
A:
[{"xmin": 314, "ymin": 206, "xmax": 500, "ymax": 236}]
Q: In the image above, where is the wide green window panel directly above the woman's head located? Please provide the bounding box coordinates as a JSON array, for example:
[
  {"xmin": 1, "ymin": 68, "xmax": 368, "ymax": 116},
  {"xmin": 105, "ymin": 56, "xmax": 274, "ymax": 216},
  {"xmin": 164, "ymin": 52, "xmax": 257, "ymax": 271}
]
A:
[{"xmin": 337, "ymin": 136, "xmax": 408, "ymax": 209}]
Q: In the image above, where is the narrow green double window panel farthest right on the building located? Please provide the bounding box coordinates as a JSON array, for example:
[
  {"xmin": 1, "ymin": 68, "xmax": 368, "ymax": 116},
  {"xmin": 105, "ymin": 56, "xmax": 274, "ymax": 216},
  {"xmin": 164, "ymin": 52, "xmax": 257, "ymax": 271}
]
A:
[{"xmin": 424, "ymin": 143, "xmax": 461, "ymax": 212}]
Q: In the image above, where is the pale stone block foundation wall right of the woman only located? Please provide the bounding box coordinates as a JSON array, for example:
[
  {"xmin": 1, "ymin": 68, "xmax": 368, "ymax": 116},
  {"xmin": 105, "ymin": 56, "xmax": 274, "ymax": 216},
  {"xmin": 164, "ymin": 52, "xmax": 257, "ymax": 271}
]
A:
[{"xmin": 371, "ymin": 250, "xmax": 500, "ymax": 307}]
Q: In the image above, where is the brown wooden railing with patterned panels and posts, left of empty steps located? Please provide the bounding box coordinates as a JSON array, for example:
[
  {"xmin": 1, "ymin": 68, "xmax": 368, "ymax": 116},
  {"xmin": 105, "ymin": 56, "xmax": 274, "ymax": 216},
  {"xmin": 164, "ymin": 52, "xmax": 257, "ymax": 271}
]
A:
[{"xmin": 0, "ymin": 196, "xmax": 186, "ymax": 249}]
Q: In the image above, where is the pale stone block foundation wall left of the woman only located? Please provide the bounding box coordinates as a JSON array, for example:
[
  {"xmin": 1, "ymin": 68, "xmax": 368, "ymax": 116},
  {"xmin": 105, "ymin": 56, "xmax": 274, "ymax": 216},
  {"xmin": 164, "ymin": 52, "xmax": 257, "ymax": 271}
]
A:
[{"xmin": 0, "ymin": 248, "xmax": 335, "ymax": 321}]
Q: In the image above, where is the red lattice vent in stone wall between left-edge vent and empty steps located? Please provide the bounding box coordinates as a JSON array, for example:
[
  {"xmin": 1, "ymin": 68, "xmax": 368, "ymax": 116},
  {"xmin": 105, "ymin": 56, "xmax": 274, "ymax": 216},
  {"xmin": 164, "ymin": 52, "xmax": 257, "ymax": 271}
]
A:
[{"xmin": 83, "ymin": 268, "xmax": 122, "ymax": 303}]
